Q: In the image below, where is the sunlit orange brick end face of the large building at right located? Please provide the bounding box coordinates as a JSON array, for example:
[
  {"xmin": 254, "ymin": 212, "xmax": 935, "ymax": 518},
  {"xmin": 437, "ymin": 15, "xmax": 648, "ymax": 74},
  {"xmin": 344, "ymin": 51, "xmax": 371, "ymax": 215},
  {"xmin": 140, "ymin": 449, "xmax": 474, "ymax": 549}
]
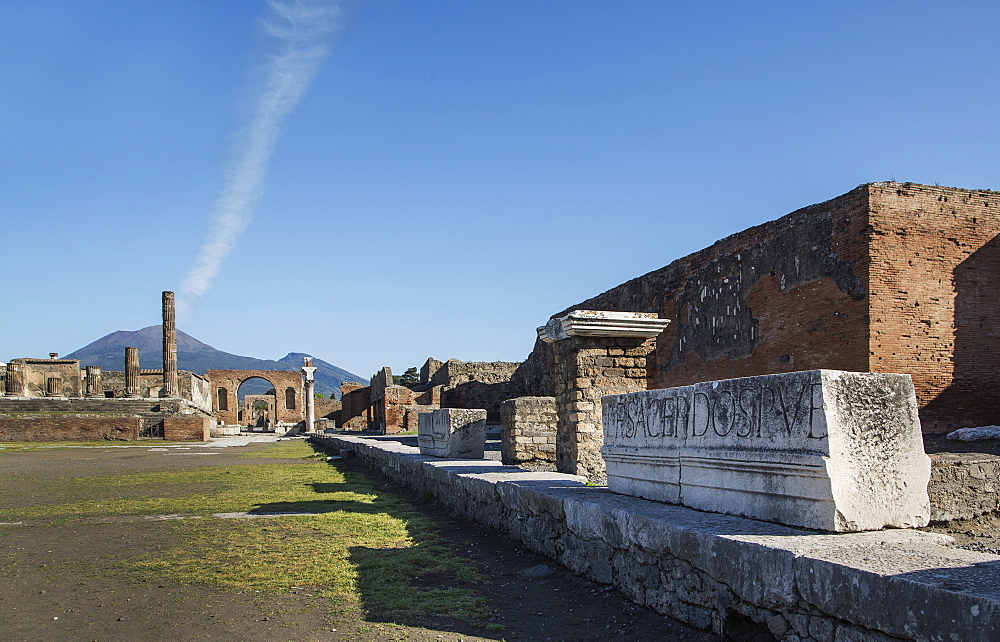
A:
[{"xmin": 867, "ymin": 183, "xmax": 1000, "ymax": 432}]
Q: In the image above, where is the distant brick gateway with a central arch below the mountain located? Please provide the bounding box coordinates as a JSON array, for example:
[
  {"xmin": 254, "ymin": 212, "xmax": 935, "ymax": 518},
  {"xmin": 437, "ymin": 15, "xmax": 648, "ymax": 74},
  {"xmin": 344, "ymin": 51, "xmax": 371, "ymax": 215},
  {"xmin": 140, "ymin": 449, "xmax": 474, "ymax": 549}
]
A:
[{"xmin": 205, "ymin": 370, "xmax": 305, "ymax": 425}]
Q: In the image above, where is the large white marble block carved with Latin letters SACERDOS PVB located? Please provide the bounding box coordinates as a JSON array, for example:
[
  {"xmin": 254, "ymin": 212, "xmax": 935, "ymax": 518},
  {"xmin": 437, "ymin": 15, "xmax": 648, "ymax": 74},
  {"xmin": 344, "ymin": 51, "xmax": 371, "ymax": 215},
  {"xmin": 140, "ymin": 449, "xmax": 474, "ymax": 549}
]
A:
[{"xmin": 602, "ymin": 370, "xmax": 930, "ymax": 532}]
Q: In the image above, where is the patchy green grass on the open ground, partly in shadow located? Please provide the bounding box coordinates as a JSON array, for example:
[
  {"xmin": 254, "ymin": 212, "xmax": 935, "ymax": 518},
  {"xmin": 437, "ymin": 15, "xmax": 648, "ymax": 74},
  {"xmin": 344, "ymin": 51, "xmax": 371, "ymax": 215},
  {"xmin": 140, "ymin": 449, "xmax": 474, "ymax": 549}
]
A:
[{"xmin": 0, "ymin": 441, "xmax": 490, "ymax": 628}]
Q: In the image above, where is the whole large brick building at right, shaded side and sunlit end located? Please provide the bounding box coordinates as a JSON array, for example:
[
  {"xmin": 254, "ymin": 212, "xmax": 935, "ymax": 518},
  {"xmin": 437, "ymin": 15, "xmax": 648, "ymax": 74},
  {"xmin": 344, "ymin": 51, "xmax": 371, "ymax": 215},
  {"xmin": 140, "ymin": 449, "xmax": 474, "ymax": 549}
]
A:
[{"xmin": 512, "ymin": 182, "xmax": 1000, "ymax": 433}]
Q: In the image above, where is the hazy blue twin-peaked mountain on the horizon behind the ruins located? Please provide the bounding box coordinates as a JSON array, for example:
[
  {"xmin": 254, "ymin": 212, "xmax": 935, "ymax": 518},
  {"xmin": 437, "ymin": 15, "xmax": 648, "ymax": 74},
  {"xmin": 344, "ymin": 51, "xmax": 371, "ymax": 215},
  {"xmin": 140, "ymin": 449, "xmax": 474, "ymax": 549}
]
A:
[{"xmin": 63, "ymin": 325, "xmax": 368, "ymax": 398}]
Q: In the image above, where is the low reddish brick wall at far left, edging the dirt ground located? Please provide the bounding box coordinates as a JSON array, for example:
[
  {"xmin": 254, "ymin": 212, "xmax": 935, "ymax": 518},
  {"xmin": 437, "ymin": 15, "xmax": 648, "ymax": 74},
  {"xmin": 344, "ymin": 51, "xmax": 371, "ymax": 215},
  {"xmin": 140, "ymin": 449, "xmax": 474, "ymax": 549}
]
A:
[{"xmin": 0, "ymin": 414, "xmax": 142, "ymax": 442}]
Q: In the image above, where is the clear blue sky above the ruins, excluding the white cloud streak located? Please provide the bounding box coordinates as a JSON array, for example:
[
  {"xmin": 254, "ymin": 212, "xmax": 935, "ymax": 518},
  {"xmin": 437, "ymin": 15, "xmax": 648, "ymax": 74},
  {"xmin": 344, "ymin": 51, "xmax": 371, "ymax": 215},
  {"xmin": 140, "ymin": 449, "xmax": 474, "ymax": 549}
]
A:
[{"xmin": 0, "ymin": 0, "xmax": 1000, "ymax": 376}]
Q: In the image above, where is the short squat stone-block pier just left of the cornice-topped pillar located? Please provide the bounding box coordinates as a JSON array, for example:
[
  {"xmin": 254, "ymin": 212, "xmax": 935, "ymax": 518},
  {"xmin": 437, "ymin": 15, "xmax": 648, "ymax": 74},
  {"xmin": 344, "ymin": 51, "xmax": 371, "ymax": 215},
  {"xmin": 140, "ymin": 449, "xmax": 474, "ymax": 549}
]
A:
[{"xmin": 500, "ymin": 397, "xmax": 556, "ymax": 464}]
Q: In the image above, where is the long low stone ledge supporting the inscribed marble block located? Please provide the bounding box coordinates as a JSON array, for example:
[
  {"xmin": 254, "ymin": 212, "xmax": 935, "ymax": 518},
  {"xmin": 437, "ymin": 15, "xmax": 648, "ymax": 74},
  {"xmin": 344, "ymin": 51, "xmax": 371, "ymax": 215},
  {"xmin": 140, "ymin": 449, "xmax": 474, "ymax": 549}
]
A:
[{"xmin": 311, "ymin": 435, "xmax": 1000, "ymax": 642}]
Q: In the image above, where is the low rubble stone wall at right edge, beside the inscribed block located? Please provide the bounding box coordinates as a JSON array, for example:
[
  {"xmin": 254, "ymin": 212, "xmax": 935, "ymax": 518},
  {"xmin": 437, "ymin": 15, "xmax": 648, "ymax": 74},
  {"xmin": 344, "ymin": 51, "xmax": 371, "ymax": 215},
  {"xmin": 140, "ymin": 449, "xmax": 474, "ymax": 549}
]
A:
[{"xmin": 927, "ymin": 453, "xmax": 1000, "ymax": 522}]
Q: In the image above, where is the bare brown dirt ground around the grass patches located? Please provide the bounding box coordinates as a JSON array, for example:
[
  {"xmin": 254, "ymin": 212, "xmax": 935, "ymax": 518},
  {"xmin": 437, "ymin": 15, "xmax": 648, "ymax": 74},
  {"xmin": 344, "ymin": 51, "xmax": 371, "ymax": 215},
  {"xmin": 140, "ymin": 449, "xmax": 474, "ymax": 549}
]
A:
[{"xmin": 0, "ymin": 445, "xmax": 717, "ymax": 642}]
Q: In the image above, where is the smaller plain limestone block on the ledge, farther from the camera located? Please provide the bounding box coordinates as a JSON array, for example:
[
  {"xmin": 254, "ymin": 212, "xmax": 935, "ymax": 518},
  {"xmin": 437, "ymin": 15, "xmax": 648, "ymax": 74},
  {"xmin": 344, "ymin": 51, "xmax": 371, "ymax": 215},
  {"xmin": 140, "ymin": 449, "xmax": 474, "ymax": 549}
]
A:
[{"xmin": 417, "ymin": 408, "xmax": 486, "ymax": 459}]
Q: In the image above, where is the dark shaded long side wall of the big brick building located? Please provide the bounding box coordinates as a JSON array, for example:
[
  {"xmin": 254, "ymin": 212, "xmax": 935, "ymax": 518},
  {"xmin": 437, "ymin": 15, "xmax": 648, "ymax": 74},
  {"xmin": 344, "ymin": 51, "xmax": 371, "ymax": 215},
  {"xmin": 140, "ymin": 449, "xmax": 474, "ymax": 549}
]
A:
[{"xmin": 515, "ymin": 186, "xmax": 868, "ymax": 394}]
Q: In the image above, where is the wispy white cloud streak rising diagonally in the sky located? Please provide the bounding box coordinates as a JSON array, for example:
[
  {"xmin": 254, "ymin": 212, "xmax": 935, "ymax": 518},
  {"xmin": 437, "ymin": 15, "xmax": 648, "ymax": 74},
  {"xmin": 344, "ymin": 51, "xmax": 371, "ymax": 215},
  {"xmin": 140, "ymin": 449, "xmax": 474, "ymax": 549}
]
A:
[{"xmin": 178, "ymin": 0, "xmax": 340, "ymax": 315}]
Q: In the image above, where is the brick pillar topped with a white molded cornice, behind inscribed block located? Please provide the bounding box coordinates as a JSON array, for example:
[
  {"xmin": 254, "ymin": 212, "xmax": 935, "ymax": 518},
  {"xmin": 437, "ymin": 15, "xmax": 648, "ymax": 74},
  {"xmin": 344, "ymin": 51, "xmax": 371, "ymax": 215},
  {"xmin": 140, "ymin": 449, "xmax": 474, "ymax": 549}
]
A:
[{"xmin": 538, "ymin": 310, "xmax": 670, "ymax": 481}]
